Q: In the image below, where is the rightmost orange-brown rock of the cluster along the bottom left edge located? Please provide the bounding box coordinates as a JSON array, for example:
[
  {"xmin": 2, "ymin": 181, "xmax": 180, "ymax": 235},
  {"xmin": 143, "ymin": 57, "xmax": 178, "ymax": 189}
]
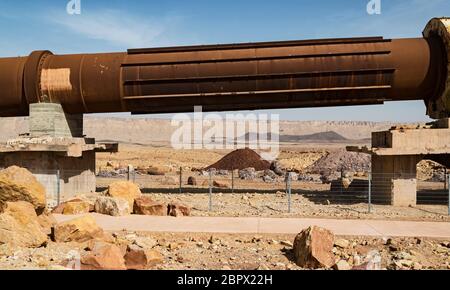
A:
[{"xmin": 124, "ymin": 245, "xmax": 164, "ymax": 270}]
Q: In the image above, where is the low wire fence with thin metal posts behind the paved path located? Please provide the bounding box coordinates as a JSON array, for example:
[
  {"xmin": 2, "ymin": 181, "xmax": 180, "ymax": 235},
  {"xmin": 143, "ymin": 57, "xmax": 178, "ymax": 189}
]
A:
[{"xmin": 1, "ymin": 167, "xmax": 450, "ymax": 218}]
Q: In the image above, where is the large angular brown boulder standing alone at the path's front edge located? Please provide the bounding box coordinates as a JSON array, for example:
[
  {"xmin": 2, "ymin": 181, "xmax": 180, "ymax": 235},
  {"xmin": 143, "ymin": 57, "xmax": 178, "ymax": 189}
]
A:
[{"xmin": 294, "ymin": 226, "xmax": 335, "ymax": 269}]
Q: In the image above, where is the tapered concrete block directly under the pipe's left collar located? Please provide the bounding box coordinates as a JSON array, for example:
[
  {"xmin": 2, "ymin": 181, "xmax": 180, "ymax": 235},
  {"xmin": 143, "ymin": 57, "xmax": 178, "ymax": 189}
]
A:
[{"xmin": 29, "ymin": 103, "xmax": 83, "ymax": 138}]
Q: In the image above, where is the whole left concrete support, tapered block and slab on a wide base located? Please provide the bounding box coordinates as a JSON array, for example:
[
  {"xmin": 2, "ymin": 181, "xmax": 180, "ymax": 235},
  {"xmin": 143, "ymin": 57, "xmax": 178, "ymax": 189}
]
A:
[{"xmin": 0, "ymin": 103, "xmax": 118, "ymax": 206}]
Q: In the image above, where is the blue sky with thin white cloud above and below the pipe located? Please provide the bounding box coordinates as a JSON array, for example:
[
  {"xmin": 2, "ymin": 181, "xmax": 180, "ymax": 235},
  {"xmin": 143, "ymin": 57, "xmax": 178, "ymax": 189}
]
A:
[{"xmin": 0, "ymin": 0, "xmax": 450, "ymax": 122}]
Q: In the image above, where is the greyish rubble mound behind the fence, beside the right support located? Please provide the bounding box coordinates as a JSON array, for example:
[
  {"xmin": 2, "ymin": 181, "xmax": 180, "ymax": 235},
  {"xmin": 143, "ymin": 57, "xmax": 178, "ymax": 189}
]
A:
[{"xmin": 307, "ymin": 150, "xmax": 371, "ymax": 173}]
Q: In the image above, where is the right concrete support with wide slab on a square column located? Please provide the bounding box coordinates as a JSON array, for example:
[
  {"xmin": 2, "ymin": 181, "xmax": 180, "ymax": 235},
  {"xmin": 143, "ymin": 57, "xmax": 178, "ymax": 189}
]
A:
[{"xmin": 347, "ymin": 119, "xmax": 450, "ymax": 206}]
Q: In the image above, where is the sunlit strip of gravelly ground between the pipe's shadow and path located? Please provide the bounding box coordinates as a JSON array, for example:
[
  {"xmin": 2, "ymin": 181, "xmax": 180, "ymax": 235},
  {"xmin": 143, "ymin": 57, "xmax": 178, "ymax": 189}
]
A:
[{"xmin": 142, "ymin": 192, "xmax": 450, "ymax": 221}]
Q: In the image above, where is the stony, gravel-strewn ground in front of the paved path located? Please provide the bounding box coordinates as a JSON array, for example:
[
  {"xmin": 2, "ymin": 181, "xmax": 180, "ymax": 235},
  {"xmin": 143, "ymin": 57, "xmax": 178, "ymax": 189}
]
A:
[{"xmin": 0, "ymin": 232, "xmax": 450, "ymax": 270}]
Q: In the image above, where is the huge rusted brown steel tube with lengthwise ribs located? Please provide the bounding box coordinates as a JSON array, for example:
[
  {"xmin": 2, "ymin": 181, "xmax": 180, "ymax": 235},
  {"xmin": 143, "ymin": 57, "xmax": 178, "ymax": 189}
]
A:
[{"xmin": 0, "ymin": 33, "xmax": 446, "ymax": 116}]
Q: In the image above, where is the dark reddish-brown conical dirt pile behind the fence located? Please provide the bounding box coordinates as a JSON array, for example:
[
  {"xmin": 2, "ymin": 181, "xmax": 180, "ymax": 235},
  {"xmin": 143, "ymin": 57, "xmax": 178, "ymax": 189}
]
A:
[{"xmin": 206, "ymin": 148, "xmax": 270, "ymax": 171}]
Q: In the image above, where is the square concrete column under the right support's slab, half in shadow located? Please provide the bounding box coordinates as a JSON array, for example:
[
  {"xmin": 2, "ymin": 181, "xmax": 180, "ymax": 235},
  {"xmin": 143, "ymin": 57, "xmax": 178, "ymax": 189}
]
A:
[{"xmin": 372, "ymin": 155, "xmax": 422, "ymax": 206}]
